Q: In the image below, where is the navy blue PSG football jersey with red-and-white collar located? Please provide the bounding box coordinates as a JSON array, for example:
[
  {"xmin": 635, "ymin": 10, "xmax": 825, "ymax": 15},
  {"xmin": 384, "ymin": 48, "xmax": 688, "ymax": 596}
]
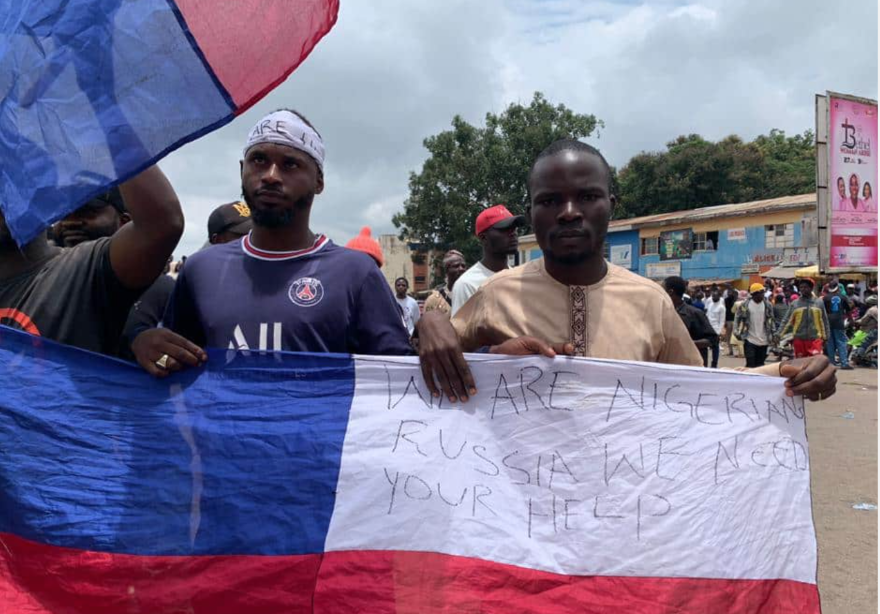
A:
[{"xmin": 164, "ymin": 236, "xmax": 412, "ymax": 355}]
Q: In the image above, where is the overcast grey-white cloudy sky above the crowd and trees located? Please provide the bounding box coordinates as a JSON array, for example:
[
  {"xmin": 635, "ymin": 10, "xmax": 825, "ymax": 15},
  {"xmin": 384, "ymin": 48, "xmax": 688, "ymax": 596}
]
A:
[{"xmin": 161, "ymin": 0, "xmax": 878, "ymax": 257}]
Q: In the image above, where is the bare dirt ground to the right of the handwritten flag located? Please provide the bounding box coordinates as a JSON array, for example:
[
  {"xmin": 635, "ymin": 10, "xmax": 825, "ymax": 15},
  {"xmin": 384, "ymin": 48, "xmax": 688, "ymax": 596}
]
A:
[{"xmin": 721, "ymin": 358, "xmax": 877, "ymax": 614}]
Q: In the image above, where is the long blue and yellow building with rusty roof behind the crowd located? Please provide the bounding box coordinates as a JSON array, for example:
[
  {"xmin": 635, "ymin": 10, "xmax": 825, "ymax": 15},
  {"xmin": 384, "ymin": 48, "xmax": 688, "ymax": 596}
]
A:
[{"xmin": 519, "ymin": 194, "xmax": 818, "ymax": 289}]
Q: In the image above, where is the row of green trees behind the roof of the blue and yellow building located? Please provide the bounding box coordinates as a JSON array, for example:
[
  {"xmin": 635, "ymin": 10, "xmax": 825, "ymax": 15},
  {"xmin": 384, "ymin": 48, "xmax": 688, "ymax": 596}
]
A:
[{"xmin": 616, "ymin": 129, "xmax": 815, "ymax": 217}]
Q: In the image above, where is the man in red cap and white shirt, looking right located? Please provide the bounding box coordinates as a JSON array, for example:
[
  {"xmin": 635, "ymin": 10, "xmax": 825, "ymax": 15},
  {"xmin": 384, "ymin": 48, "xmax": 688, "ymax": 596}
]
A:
[{"xmin": 451, "ymin": 205, "xmax": 525, "ymax": 316}]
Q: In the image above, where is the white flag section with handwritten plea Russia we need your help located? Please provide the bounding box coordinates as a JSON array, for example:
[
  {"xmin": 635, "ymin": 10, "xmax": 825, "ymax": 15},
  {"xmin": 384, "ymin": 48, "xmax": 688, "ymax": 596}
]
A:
[{"xmin": 326, "ymin": 355, "xmax": 816, "ymax": 583}]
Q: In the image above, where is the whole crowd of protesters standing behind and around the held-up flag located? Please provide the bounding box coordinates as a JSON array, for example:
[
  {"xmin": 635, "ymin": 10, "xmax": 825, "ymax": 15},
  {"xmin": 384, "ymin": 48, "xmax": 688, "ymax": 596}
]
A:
[{"xmin": 0, "ymin": 109, "xmax": 840, "ymax": 402}]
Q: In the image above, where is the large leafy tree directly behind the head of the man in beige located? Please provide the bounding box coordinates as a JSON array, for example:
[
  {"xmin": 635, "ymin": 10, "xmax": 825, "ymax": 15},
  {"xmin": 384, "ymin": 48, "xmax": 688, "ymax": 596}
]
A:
[{"xmin": 393, "ymin": 92, "xmax": 603, "ymax": 263}]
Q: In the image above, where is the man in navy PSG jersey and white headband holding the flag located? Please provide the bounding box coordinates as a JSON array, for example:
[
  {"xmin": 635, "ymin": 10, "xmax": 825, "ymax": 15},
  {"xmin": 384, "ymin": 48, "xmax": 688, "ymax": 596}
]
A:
[{"xmin": 148, "ymin": 110, "xmax": 411, "ymax": 375}]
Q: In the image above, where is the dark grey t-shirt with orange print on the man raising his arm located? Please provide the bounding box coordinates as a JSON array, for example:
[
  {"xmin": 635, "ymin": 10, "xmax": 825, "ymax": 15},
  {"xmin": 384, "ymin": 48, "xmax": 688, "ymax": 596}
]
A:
[{"xmin": 0, "ymin": 238, "xmax": 140, "ymax": 355}]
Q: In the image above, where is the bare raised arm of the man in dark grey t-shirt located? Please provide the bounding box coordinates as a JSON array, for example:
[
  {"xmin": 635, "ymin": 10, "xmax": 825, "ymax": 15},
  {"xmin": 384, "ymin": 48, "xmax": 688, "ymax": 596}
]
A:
[{"xmin": 110, "ymin": 166, "xmax": 183, "ymax": 290}]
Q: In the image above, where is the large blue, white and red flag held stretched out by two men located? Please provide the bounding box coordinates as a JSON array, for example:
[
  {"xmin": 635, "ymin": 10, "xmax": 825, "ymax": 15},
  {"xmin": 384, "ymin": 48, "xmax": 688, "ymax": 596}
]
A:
[{"xmin": 0, "ymin": 328, "xmax": 819, "ymax": 614}]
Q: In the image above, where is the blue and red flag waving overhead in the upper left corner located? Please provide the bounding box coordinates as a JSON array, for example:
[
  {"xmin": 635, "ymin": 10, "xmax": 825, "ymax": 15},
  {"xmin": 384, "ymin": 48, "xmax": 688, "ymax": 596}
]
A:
[{"xmin": 0, "ymin": 0, "xmax": 338, "ymax": 244}]
